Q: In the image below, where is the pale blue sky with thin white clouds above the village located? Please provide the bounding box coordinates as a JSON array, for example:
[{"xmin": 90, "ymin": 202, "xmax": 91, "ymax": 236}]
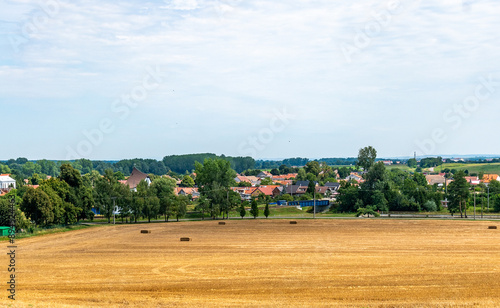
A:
[{"xmin": 0, "ymin": 0, "xmax": 500, "ymax": 160}]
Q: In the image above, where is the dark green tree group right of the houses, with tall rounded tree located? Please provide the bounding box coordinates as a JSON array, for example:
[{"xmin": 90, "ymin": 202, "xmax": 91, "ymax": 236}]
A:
[{"xmin": 336, "ymin": 147, "xmax": 500, "ymax": 217}]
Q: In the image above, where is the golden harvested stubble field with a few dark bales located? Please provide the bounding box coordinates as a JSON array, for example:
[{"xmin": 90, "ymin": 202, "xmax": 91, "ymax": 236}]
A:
[{"xmin": 0, "ymin": 219, "xmax": 500, "ymax": 307}]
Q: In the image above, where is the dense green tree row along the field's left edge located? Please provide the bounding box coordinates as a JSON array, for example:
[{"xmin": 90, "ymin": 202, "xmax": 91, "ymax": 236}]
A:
[{"xmin": 0, "ymin": 164, "xmax": 190, "ymax": 229}]
